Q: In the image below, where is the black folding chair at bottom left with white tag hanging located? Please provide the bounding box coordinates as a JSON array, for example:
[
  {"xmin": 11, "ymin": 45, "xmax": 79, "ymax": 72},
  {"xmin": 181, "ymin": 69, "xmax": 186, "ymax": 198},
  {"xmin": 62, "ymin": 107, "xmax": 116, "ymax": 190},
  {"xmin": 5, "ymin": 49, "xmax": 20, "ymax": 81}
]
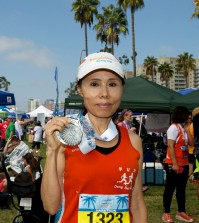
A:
[{"xmin": 2, "ymin": 154, "xmax": 49, "ymax": 223}]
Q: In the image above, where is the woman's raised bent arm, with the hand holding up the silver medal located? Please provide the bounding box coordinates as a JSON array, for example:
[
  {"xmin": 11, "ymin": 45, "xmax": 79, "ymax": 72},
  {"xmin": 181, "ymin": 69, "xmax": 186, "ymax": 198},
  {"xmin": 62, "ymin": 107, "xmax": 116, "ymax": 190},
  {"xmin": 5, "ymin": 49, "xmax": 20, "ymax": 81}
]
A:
[{"xmin": 41, "ymin": 118, "xmax": 68, "ymax": 215}]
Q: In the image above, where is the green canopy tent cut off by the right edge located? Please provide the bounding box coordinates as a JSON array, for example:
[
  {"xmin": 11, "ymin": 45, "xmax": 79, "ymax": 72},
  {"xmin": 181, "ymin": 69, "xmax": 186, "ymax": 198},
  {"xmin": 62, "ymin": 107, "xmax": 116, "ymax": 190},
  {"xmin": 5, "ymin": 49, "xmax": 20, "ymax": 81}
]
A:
[{"xmin": 173, "ymin": 89, "xmax": 199, "ymax": 111}]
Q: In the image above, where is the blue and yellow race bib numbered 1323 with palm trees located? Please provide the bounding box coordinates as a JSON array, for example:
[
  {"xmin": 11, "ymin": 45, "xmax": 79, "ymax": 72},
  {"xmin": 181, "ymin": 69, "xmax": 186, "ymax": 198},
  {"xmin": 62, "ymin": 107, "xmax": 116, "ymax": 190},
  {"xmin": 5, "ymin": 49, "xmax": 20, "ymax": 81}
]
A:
[{"xmin": 78, "ymin": 194, "xmax": 130, "ymax": 223}]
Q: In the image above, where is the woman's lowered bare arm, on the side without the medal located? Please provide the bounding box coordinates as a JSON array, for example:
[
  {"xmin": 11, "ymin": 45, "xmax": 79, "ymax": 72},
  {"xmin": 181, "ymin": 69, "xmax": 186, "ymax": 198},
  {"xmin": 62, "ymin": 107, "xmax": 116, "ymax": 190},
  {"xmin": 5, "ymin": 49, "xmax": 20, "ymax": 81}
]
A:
[{"xmin": 129, "ymin": 132, "xmax": 148, "ymax": 223}]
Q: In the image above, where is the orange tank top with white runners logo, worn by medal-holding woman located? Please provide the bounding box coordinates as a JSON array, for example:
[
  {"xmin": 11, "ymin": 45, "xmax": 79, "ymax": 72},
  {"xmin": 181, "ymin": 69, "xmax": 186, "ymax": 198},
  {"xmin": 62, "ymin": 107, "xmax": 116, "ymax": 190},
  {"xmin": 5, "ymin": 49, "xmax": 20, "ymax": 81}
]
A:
[{"xmin": 58, "ymin": 127, "xmax": 140, "ymax": 223}]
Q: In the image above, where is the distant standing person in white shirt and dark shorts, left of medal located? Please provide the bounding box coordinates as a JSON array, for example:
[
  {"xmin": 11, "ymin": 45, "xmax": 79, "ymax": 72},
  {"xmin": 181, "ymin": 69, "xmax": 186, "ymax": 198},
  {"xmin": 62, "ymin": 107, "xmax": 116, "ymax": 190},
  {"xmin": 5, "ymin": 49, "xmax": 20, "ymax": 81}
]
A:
[{"xmin": 32, "ymin": 121, "xmax": 43, "ymax": 156}]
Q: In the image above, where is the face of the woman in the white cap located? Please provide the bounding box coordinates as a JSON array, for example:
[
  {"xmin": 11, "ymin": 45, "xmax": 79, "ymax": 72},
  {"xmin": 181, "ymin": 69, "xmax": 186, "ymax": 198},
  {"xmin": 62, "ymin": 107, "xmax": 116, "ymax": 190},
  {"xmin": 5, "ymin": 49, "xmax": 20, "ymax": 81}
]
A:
[{"xmin": 77, "ymin": 70, "xmax": 123, "ymax": 118}]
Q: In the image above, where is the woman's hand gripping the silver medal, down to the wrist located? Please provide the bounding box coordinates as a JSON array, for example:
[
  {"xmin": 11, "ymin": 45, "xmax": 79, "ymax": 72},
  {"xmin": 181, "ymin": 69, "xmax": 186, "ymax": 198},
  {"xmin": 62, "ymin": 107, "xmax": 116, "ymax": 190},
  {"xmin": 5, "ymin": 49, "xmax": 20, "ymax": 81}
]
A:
[{"xmin": 45, "ymin": 117, "xmax": 70, "ymax": 151}]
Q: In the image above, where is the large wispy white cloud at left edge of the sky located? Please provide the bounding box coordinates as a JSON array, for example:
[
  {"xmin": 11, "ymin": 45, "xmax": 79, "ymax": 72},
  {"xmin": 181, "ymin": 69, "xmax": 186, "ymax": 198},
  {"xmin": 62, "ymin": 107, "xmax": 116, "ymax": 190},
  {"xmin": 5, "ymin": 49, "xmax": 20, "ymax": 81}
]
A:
[{"xmin": 0, "ymin": 36, "xmax": 54, "ymax": 67}]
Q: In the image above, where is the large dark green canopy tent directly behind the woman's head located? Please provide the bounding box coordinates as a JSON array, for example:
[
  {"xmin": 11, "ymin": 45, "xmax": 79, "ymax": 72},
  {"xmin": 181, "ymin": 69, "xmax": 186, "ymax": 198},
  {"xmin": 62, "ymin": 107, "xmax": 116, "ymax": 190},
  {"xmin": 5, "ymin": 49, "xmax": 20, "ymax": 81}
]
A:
[{"xmin": 65, "ymin": 77, "xmax": 183, "ymax": 114}]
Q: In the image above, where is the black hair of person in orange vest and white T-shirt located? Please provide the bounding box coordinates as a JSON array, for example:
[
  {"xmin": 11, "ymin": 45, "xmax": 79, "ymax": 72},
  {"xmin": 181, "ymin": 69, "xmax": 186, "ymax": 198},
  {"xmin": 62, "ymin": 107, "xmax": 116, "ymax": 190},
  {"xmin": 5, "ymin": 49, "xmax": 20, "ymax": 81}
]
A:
[{"xmin": 172, "ymin": 106, "xmax": 191, "ymax": 124}]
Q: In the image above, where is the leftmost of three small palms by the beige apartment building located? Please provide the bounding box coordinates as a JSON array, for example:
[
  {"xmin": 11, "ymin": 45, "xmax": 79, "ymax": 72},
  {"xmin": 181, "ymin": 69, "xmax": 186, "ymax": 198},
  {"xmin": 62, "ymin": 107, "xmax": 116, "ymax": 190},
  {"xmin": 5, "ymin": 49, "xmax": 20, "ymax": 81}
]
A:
[{"xmin": 144, "ymin": 56, "xmax": 158, "ymax": 81}]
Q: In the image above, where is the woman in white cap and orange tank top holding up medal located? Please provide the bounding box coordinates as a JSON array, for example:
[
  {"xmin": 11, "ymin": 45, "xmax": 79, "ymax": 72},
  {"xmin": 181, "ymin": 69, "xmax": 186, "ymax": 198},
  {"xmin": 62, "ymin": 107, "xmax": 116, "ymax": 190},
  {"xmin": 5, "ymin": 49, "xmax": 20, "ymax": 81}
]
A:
[{"xmin": 41, "ymin": 52, "xmax": 147, "ymax": 223}]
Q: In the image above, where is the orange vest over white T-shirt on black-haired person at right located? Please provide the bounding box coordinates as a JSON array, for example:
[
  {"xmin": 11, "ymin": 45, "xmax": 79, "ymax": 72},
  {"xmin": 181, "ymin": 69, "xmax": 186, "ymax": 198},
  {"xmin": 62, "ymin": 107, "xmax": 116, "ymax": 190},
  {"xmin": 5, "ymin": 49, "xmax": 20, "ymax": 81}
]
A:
[{"xmin": 165, "ymin": 124, "xmax": 189, "ymax": 166}]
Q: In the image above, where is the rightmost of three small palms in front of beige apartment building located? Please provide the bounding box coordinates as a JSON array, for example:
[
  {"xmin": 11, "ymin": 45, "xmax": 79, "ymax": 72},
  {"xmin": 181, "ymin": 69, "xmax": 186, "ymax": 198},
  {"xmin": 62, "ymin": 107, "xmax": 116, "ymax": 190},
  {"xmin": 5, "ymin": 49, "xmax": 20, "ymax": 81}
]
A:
[{"xmin": 175, "ymin": 52, "xmax": 196, "ymax": 88}]
